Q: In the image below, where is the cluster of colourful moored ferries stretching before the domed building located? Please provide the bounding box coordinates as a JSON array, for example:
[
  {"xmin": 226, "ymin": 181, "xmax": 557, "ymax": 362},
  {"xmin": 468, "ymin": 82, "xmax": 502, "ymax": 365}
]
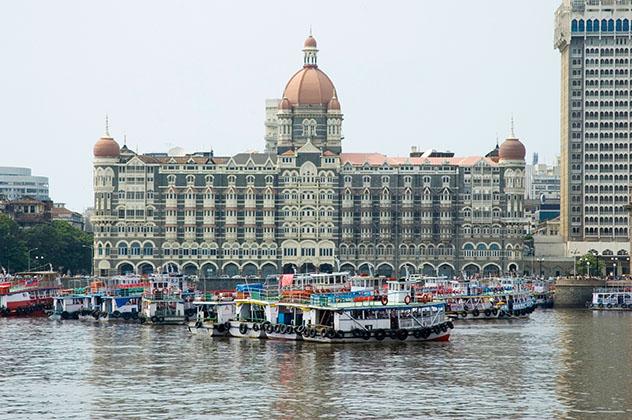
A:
[{"xmin": 0, "ymin": 272, "xmax": 550, "ymax": 343}]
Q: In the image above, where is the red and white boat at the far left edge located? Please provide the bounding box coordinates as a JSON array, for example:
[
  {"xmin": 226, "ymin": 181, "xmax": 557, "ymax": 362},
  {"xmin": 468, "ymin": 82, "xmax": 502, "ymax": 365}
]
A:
[{"xmin": 0, "ymin": 272, "xmax": 60, "ymax": 317}]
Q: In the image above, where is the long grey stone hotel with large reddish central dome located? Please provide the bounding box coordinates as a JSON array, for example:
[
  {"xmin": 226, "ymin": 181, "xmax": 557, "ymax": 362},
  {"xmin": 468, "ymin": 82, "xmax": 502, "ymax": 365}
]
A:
[{"xmin": 92, "ymin": 36, "xmax": 526, "ymax": 277}]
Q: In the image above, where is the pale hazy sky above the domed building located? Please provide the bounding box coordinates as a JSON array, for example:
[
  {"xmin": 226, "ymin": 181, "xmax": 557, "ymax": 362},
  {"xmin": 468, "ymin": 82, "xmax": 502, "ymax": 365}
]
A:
[{"xmin": 0, "ymin": 0, "xmax": 560, "ymax": 211}]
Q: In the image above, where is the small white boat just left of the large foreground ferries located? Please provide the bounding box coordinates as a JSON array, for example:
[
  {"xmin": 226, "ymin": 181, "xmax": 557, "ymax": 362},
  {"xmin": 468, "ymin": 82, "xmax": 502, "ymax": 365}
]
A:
[{"xmin": 188, "ymin": 298, "xmax": 236, "ymax": 337}]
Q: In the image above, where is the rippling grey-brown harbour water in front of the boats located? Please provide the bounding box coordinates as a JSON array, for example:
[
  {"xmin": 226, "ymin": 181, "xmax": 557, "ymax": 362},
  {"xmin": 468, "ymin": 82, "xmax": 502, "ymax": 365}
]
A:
[{"xmin": 0, "ymin": 311, "xmax": 632, "ymax": 418}]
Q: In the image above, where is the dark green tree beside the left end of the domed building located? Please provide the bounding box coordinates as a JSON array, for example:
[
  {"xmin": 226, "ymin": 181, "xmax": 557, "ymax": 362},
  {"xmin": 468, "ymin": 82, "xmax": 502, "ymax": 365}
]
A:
[{"xmin": 25, "ymin": 220, "xmax": 93, "ymax": 274}]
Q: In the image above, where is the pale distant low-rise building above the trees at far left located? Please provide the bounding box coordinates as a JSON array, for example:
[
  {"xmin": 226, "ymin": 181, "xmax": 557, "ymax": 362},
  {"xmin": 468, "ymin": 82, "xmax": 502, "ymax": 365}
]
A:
[{"xmin": 0, "ymin": 166, "xmax": 48, "ymax": 200}]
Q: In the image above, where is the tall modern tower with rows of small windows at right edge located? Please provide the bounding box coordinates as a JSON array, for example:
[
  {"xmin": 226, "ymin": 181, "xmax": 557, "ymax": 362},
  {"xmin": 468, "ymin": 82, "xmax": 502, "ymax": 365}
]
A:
[{"xmin": 555, "ymin": 0, "xmax": 632, "ymax": 259}]
